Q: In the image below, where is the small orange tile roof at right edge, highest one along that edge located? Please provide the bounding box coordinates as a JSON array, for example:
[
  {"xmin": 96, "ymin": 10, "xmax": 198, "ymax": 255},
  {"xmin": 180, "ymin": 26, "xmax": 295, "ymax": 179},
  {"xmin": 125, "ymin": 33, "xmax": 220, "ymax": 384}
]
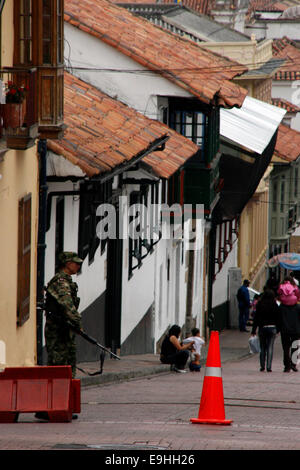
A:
[{"xmin": 272, "ymin": 36, "xmax": 300, "ymax": 80}]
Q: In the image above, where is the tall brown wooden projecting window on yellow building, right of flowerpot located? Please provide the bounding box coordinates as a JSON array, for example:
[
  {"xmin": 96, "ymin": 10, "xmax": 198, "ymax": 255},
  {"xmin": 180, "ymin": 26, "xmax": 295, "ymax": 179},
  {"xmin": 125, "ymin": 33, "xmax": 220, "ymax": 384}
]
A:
[{"xmin": 14, "ymin": 0, "xmax": 64, "ymax": 139}]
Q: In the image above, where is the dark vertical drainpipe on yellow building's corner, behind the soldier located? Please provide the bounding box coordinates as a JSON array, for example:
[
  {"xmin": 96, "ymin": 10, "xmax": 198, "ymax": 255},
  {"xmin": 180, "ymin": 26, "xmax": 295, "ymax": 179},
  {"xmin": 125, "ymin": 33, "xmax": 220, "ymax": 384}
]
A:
[{"xmin": 36, "ymin": 139, "xmax": 48, "ymax": 365}]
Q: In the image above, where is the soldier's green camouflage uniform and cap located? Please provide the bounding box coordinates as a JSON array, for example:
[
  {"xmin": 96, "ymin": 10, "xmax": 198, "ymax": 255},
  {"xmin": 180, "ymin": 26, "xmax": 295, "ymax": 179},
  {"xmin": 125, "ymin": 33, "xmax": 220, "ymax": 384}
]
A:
[{"xmin": 45, "ymin": 252, "xmax": 82, "ymax": 377}]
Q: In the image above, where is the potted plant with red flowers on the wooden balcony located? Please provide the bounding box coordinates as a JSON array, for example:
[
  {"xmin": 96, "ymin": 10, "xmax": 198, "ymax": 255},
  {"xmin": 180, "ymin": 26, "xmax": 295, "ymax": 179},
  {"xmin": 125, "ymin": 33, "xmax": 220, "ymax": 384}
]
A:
[{"xmin": 3, "ymin": 81, "xmax": 28, "ymax": 129}]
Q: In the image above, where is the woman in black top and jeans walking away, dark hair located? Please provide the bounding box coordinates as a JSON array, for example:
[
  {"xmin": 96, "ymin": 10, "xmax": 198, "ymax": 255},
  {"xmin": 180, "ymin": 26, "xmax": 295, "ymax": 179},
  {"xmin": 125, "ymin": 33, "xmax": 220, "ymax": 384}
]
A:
[{"xmin": 251, "ymin": 289, "xmax": 280, "ymax": 372}]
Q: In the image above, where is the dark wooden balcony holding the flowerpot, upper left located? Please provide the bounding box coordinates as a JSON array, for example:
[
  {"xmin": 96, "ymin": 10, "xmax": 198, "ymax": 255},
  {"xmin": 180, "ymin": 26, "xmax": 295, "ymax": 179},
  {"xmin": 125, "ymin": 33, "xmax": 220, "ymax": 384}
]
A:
[{"xmin": 0, "ymin": 67, "xmax": 38, "ymax": 150}]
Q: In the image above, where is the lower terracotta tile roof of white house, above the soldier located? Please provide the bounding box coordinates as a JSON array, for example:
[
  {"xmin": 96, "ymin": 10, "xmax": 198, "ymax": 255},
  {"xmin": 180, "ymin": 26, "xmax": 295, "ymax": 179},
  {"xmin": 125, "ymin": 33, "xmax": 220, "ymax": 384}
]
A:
[{"xmin": 47, "ymin": 73, "xmax": 198, "ymax": 178}]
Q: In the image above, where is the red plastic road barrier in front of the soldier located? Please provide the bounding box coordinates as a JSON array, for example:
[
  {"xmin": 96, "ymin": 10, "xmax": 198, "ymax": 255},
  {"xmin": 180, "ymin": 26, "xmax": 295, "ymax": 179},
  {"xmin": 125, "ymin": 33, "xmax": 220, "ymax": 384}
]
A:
[{"xmin": 0, "ymin": 366, "xmax": 80, "ymax": 423}]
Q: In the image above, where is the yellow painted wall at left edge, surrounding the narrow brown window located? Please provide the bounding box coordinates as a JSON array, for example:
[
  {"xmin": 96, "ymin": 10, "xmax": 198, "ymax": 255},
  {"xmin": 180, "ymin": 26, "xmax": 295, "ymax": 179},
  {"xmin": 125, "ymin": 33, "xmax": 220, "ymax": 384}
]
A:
[{"xmin": 0, "ymin": 0, "xmax": 38, "ymax": 369}]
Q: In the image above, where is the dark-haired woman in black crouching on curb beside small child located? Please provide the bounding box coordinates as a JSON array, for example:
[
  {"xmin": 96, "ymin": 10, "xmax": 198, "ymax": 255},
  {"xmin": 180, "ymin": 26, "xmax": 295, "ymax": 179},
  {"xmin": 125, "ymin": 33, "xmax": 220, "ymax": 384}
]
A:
[{"xmin": 160, "ymin": 325, "xmax": 194, "ymax": 372}]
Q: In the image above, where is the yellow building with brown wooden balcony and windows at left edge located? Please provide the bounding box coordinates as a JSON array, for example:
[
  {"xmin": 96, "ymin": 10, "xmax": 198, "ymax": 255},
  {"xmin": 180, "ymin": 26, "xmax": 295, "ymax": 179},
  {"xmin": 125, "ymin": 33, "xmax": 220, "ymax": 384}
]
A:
[{"xmin": 0, "ymin": 0, "xmax": 63, "ymax": 366}]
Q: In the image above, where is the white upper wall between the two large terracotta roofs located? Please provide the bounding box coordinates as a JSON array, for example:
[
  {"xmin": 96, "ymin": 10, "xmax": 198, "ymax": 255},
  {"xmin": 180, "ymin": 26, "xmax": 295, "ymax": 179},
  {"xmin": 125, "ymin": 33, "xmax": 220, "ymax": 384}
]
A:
[{"xmin": 65, "ymin": 23, "xmax": 192, "ymax": 119}]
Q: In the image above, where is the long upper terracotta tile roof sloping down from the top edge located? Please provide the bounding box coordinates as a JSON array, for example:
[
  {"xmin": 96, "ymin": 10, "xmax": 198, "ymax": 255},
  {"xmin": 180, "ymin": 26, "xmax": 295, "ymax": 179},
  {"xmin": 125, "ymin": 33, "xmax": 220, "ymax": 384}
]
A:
[{"xmin": 64, "ymin": 0, "xmax": 247, "ymax": 107}]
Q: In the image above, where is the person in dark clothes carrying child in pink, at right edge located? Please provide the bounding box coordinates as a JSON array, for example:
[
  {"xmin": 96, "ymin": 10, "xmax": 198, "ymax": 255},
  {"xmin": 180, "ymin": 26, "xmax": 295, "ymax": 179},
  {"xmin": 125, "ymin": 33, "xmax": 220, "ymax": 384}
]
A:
[{"xmin": 278, "ymin": 276, "xmax": 300, "ymax": 372}]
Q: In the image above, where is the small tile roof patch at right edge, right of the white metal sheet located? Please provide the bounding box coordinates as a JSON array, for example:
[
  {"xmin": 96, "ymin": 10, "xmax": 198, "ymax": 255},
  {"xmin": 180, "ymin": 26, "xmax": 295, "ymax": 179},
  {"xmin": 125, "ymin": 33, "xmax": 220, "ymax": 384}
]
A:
[{"xmin": 274, "ymin": 124, "xmax": 300, "ymax": 162}]
